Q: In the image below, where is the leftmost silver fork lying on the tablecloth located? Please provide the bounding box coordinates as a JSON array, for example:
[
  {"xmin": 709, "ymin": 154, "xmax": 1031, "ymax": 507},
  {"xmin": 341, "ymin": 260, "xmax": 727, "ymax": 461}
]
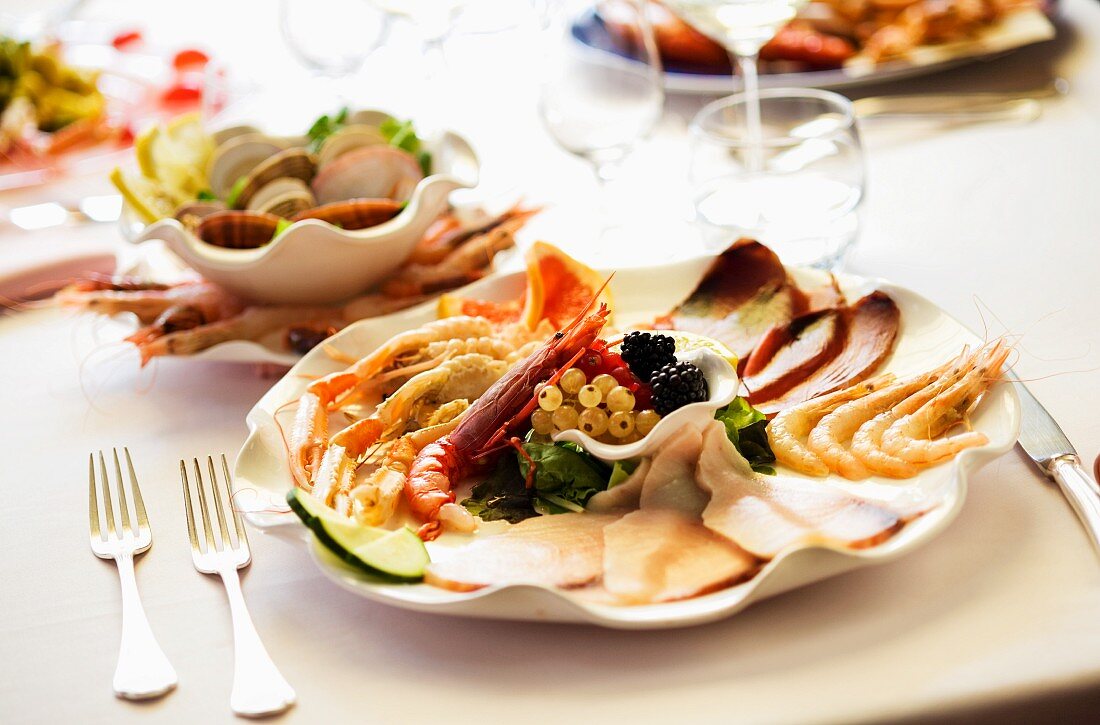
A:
[{"xmin": 88, "ymin": 448, "xmax": 177, "ymax": 700}]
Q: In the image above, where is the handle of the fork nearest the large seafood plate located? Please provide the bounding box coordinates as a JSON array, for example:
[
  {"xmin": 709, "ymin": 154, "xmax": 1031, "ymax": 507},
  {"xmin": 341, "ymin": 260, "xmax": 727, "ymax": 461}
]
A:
[{"xmin": 219, "ymin": 569, "xmax": 296, "ymax": 717}]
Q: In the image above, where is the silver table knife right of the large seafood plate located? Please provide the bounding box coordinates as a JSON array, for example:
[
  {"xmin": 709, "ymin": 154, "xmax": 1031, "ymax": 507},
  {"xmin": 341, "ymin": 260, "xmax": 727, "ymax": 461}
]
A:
[{"xmin": 1011, "ymin": 375, "xmax": 1100, "ymax": 554}]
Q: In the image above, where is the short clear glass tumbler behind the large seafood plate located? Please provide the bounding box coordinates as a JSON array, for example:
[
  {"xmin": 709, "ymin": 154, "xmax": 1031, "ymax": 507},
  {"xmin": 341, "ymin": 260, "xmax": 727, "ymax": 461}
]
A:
[{"xmin": 690, "ymin": 89, "xmax": 865, "ymax": 270}]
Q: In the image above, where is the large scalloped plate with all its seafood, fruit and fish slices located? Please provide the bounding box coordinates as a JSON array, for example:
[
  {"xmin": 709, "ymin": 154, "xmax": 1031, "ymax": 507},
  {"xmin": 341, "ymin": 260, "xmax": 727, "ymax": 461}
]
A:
[{"xmin": 234, "ymin": 240, "xmax": 1020, "ymax": 628}]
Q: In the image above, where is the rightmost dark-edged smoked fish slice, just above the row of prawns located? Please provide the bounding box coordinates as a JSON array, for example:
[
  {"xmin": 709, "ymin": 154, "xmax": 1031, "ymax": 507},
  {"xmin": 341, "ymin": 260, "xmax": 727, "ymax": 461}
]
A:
[{"xmin": 745, "ymin": 292, "xmax": 901, "ymax": 415}]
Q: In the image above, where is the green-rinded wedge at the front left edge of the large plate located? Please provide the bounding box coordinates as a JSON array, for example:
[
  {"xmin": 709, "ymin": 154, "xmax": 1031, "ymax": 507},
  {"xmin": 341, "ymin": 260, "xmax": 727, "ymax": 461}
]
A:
[{"xmin": 286, "ymin": 488, "xmax": 429, "ymax": 581}]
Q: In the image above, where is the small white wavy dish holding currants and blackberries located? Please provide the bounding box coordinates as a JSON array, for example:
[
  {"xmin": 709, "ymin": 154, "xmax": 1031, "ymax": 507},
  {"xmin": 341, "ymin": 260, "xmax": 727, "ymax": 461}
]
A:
[{"xmin": 553, "ymin": 349, "xmax": 738, "ymax": 461}]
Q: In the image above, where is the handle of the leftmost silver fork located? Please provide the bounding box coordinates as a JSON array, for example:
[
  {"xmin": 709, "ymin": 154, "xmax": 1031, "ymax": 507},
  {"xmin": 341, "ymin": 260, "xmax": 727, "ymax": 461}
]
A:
[{"xmin": 113, "ymin": 554, "xmax": 177, "ymax": 700}]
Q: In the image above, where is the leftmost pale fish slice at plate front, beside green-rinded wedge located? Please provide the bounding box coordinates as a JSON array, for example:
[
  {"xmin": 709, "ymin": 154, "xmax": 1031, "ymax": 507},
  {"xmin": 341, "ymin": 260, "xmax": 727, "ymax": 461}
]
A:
[{"xmin": 425, "ymin": 514, "xmax": 617, "ymax": 592}]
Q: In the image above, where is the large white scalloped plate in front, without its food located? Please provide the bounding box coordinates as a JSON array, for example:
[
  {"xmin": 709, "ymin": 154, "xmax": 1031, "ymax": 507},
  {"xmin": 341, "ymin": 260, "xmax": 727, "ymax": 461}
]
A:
[{"xmin": 235, "ymin": 257, "xmax": 1020, "ymax": 629}]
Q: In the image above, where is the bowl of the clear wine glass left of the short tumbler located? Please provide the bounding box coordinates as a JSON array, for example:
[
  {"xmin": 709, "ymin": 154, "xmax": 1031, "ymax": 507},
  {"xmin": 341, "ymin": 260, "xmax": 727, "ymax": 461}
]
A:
[{"xmin": 539, "ymin": 0, "xmax": 664, "ymax": 196}]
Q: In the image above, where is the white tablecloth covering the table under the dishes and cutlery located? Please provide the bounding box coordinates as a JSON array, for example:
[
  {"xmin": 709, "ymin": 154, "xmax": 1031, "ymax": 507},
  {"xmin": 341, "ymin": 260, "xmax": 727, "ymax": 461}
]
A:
[{"xmin": 0, "ymin": 0, "xmax": 1100, "ymax": 723}]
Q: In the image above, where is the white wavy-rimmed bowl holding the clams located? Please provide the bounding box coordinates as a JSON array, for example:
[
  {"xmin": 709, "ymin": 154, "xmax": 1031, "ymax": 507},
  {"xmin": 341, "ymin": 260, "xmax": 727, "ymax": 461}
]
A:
[{"xmin": 134, "ymin": 112, "xmax": 480, "ymax": 305}]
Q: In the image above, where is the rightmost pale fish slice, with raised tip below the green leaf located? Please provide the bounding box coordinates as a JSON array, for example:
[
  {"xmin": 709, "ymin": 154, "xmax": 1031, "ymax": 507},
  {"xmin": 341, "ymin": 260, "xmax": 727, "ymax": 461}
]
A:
[{"xmin": 695, "ymin": 421, "xmax": 902, "ymax": 559}]
